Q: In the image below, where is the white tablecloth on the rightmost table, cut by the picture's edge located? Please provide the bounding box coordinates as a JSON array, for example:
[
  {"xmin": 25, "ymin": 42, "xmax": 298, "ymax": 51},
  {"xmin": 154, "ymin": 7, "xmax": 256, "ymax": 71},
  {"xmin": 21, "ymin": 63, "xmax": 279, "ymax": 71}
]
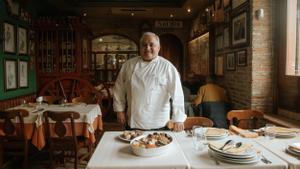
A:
[{"xmin": 255, "ymin": 134, "xmax": 300, "ymax": 169}]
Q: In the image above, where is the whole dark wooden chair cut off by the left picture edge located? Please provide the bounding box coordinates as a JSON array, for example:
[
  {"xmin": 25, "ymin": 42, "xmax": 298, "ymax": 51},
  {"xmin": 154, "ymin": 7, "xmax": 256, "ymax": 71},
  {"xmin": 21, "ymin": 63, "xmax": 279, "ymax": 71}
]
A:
[{"xmin": 0, "ymin": 109, "xmax": 29, "ymax": 169}]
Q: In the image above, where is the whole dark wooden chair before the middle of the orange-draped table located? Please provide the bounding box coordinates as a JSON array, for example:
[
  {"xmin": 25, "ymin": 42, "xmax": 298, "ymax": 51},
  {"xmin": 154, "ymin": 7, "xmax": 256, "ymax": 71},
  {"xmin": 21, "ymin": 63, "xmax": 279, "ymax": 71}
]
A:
[{"xmin": 44, "ymin": 111, "xmax": 84, "ymax": 169}]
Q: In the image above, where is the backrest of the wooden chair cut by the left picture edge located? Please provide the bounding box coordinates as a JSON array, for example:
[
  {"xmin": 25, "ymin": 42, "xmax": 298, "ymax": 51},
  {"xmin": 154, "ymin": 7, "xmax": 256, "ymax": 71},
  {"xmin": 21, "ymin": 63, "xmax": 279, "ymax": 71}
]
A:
[{"xmin": 0, "ymin": 109, "xmax": 29, "ymax": 140}]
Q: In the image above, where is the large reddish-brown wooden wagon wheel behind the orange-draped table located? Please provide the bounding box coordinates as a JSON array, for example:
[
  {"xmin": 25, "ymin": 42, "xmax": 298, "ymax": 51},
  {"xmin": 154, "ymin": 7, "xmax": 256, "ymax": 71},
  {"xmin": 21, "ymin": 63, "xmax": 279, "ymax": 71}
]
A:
[{"xmin": 39, "ymin": 77, "xmax": 112, "ymax": 116}]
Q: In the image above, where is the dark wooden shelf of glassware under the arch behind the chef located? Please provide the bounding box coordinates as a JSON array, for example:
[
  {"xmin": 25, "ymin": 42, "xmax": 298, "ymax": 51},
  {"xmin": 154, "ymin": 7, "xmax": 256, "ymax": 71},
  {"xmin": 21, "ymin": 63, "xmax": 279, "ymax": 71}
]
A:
[{"xmin": 93, "ymin": 51, "xmax": 137, "ymax": 84}]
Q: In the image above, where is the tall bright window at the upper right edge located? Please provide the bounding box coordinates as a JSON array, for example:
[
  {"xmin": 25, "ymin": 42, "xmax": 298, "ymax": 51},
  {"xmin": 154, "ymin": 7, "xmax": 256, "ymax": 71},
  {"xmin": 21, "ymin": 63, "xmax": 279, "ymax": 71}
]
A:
[{"xmin": 286, "ymin": 0, "xmax": 300, "ymax": 76}]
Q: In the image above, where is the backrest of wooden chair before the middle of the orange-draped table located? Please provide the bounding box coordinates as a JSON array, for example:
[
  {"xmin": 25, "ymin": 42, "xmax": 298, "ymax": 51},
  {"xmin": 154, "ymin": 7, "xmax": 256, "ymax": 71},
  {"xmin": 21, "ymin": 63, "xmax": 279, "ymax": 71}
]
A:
[{"xmin": 44, "ymin": 111, "xmax": 80, "ymax": 151}]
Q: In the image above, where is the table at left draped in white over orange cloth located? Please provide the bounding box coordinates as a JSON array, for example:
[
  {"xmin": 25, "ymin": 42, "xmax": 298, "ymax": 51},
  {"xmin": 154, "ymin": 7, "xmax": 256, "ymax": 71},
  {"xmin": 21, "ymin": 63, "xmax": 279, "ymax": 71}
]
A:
[{"xmin": 4, "ymin": 103, "xmax": 103, "ymax": 150}]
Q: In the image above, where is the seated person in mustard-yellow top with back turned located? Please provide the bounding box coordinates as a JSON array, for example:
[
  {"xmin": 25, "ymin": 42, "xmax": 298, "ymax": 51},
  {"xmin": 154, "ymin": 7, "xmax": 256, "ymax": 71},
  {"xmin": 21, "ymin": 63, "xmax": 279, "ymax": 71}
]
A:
[{"xmin": 193, "ymin": 75, "xmax": 229, "ymax": 128}]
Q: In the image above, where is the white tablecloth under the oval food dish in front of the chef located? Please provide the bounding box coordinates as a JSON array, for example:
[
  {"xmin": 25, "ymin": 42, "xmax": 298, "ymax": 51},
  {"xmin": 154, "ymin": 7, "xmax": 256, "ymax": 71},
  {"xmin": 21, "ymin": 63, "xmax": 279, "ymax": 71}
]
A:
[{"xmin": 87, "ymin": 132, "xmax": 189, "ymax": 169}]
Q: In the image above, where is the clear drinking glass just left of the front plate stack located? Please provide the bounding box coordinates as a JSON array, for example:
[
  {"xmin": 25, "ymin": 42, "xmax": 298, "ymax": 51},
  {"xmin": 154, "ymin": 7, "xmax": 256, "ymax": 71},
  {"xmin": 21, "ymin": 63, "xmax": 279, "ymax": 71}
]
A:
[{"xmin": 192, "ymin": 126, "xmax": 206, "ymax": 151}]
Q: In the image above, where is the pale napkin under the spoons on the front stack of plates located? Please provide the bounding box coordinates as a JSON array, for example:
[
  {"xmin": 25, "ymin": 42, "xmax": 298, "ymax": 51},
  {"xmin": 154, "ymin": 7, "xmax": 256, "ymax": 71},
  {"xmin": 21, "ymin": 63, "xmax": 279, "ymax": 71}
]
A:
[{"xmin": 209, "ymin": 142, "xmax": 254, "ymax": 155}]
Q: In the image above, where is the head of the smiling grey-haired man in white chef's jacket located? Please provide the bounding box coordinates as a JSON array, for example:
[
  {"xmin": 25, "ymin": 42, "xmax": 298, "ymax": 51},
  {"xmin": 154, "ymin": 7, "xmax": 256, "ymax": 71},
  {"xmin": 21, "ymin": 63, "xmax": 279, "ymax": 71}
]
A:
[{"xmin": 140, "ymin": 35, "xmax": 160, "ymax": 61}]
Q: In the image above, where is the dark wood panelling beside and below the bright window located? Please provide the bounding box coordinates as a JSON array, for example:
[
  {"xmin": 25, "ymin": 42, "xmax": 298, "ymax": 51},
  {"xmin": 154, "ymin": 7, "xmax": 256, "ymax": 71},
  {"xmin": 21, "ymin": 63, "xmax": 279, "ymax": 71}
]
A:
[{"xmin": 273, "ymin": 0, "xmax": 300, "ymax": 113}]
